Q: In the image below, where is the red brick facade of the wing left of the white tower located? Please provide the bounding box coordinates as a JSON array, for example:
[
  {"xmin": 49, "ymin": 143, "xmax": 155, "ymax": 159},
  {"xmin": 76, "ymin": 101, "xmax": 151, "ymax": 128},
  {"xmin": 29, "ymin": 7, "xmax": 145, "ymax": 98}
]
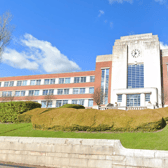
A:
[{"xmin": 0, "ymin": 61, "xmax": 112, "ymax": 105}]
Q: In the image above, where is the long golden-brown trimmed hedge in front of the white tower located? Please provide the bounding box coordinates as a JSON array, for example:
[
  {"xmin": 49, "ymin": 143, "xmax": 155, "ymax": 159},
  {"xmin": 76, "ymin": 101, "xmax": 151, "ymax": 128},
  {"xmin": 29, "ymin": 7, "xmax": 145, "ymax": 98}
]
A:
[{"xmin": 28, "ymin": 108, "xmax": 166, "ymax": 132}]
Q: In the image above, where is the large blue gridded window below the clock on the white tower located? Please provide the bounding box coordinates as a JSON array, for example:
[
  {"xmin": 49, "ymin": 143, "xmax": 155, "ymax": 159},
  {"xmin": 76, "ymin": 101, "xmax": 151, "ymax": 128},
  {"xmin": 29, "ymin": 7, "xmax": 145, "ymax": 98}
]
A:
[{"xmin": 127, "ymin": 64, "xmax": 144, "ymax": 88}]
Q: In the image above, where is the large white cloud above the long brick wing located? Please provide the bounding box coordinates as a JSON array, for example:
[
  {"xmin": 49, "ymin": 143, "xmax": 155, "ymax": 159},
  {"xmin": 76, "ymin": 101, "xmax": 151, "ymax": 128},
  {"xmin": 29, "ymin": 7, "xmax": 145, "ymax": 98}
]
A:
[{"xmin": 2, "ymin": 34, "xmax": 80, "ymax": 73}]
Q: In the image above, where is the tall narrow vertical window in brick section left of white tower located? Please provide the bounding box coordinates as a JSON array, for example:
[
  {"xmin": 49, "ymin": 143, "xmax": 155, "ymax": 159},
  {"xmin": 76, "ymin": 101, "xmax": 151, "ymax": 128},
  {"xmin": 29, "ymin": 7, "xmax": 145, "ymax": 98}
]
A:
[{"xmin": 101, "ymin": 69, "xmax": 109, "ymax": 104}]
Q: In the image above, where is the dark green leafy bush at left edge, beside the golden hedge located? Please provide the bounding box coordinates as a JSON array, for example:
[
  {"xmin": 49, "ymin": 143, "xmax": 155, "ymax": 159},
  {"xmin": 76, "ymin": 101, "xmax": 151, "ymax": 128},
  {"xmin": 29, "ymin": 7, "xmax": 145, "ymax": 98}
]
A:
[{"xmin": 0, "ymin": 101, "xmax": 41, "ymax": 123}]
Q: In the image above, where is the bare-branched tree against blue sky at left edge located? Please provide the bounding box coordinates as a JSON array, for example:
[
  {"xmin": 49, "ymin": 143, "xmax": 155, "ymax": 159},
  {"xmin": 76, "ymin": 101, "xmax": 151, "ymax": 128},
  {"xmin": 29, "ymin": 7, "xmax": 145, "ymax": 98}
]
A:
[{"xmin": 0, "ymin": 12, "xmax": 14, "ymax": 58}]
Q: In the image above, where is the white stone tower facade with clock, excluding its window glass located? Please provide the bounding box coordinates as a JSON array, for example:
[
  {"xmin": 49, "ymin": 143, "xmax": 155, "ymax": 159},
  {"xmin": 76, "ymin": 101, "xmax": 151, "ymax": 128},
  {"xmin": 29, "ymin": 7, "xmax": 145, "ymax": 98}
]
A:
[{"xmin": 111, "ymin": 33, "xmax": 162, "ymax": 108}]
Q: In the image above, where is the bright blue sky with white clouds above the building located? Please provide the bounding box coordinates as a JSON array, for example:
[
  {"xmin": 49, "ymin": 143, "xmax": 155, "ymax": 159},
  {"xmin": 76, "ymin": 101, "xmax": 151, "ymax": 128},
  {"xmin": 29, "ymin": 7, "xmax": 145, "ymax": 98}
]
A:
[{"xmin": 0, "ymin": 0, "xmax": 168, "ymax": 77}]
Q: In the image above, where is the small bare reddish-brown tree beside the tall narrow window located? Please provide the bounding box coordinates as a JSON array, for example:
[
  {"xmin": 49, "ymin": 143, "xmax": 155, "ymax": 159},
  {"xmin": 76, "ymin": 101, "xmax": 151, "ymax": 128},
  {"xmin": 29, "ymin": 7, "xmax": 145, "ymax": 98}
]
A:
[{"xmin": 92, "ymin": 87, "xmax": 105, "ymax": 105}]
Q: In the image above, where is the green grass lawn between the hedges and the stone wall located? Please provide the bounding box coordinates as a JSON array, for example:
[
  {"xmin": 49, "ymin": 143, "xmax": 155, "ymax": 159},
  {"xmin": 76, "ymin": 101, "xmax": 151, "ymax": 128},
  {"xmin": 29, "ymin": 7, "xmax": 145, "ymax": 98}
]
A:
[{"xmin": 0, "ymin": 123, "xmax": 168, "ymax": 150}]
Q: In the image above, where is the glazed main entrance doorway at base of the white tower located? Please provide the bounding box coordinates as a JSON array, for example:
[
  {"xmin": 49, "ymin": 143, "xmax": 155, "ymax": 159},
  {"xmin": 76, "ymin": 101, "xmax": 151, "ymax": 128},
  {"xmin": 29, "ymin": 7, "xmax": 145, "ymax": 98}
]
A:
[{"xmin": 127, "ymin": 94, "xmax": 140, "ymax": 107}]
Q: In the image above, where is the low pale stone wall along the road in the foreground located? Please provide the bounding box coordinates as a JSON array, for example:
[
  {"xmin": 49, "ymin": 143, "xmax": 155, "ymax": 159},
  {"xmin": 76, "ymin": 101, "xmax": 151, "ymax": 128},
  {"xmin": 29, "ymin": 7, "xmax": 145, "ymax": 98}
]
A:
[{"xmin": 0, "ymin": 136, "xmax": 168, "ymax": 168}]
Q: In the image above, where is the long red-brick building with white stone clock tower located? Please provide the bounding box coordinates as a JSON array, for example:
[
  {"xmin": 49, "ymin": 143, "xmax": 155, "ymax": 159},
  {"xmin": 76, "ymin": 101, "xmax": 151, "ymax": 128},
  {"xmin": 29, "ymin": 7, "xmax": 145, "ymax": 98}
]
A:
[{"xmin": 0, "ymin": 33, "xmax": 168, "ymax": 109}]
